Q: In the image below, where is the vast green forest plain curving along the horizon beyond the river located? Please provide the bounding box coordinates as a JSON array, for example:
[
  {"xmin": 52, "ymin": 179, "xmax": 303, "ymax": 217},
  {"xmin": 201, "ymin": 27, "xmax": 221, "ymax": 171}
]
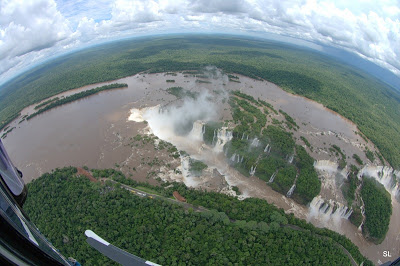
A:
[{"xmin": 0, "ymin": 35, "xmax": 400, "ymax": 167}]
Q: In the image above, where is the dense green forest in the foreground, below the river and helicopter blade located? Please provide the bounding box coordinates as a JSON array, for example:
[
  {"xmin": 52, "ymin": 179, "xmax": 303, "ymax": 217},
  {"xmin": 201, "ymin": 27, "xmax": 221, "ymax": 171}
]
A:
[{"xmin": 24, "ymin": 167, "xmax": 372, "ymax": 265}]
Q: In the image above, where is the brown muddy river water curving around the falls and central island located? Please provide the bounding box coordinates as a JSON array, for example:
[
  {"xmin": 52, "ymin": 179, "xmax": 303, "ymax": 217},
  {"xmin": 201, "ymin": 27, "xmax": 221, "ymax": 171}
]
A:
[{"xmin": 4, "ymin": 73, "xmax": 400, "ymax": 264}]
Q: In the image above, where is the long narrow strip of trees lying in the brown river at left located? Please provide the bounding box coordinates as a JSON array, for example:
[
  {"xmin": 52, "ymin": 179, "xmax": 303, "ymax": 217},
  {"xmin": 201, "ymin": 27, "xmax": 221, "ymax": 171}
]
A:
[{"xmin": 26, "ymin": 83, "xmax": 128, "ymax": 120}]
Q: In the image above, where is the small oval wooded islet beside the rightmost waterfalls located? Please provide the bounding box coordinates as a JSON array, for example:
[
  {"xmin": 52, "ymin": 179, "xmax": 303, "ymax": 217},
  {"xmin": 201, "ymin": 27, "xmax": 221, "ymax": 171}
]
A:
[{"xmin": 361, "ymin": 178, "xmax": 392, "ymax": 243}]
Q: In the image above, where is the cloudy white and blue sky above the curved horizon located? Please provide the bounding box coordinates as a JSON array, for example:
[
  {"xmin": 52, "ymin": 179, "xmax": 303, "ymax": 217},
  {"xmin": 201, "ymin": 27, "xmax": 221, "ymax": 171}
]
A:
[{"xmin": 0, "ymin": 0, "xmax": 400, "ymax": 84}]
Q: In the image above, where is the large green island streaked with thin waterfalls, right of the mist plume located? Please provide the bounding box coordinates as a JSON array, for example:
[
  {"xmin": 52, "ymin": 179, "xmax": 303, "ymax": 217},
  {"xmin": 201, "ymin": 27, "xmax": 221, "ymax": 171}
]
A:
[{"xmin": 203, "ymin": 91, "xmax": 321, "ymax": 204}]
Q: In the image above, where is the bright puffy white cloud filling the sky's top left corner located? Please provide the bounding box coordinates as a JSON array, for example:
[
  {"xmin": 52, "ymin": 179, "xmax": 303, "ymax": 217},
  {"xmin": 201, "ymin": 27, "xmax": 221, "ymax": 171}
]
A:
[{"xmin": 0, "ymin": 0, "xmax": 72, "ymax": 74}]
